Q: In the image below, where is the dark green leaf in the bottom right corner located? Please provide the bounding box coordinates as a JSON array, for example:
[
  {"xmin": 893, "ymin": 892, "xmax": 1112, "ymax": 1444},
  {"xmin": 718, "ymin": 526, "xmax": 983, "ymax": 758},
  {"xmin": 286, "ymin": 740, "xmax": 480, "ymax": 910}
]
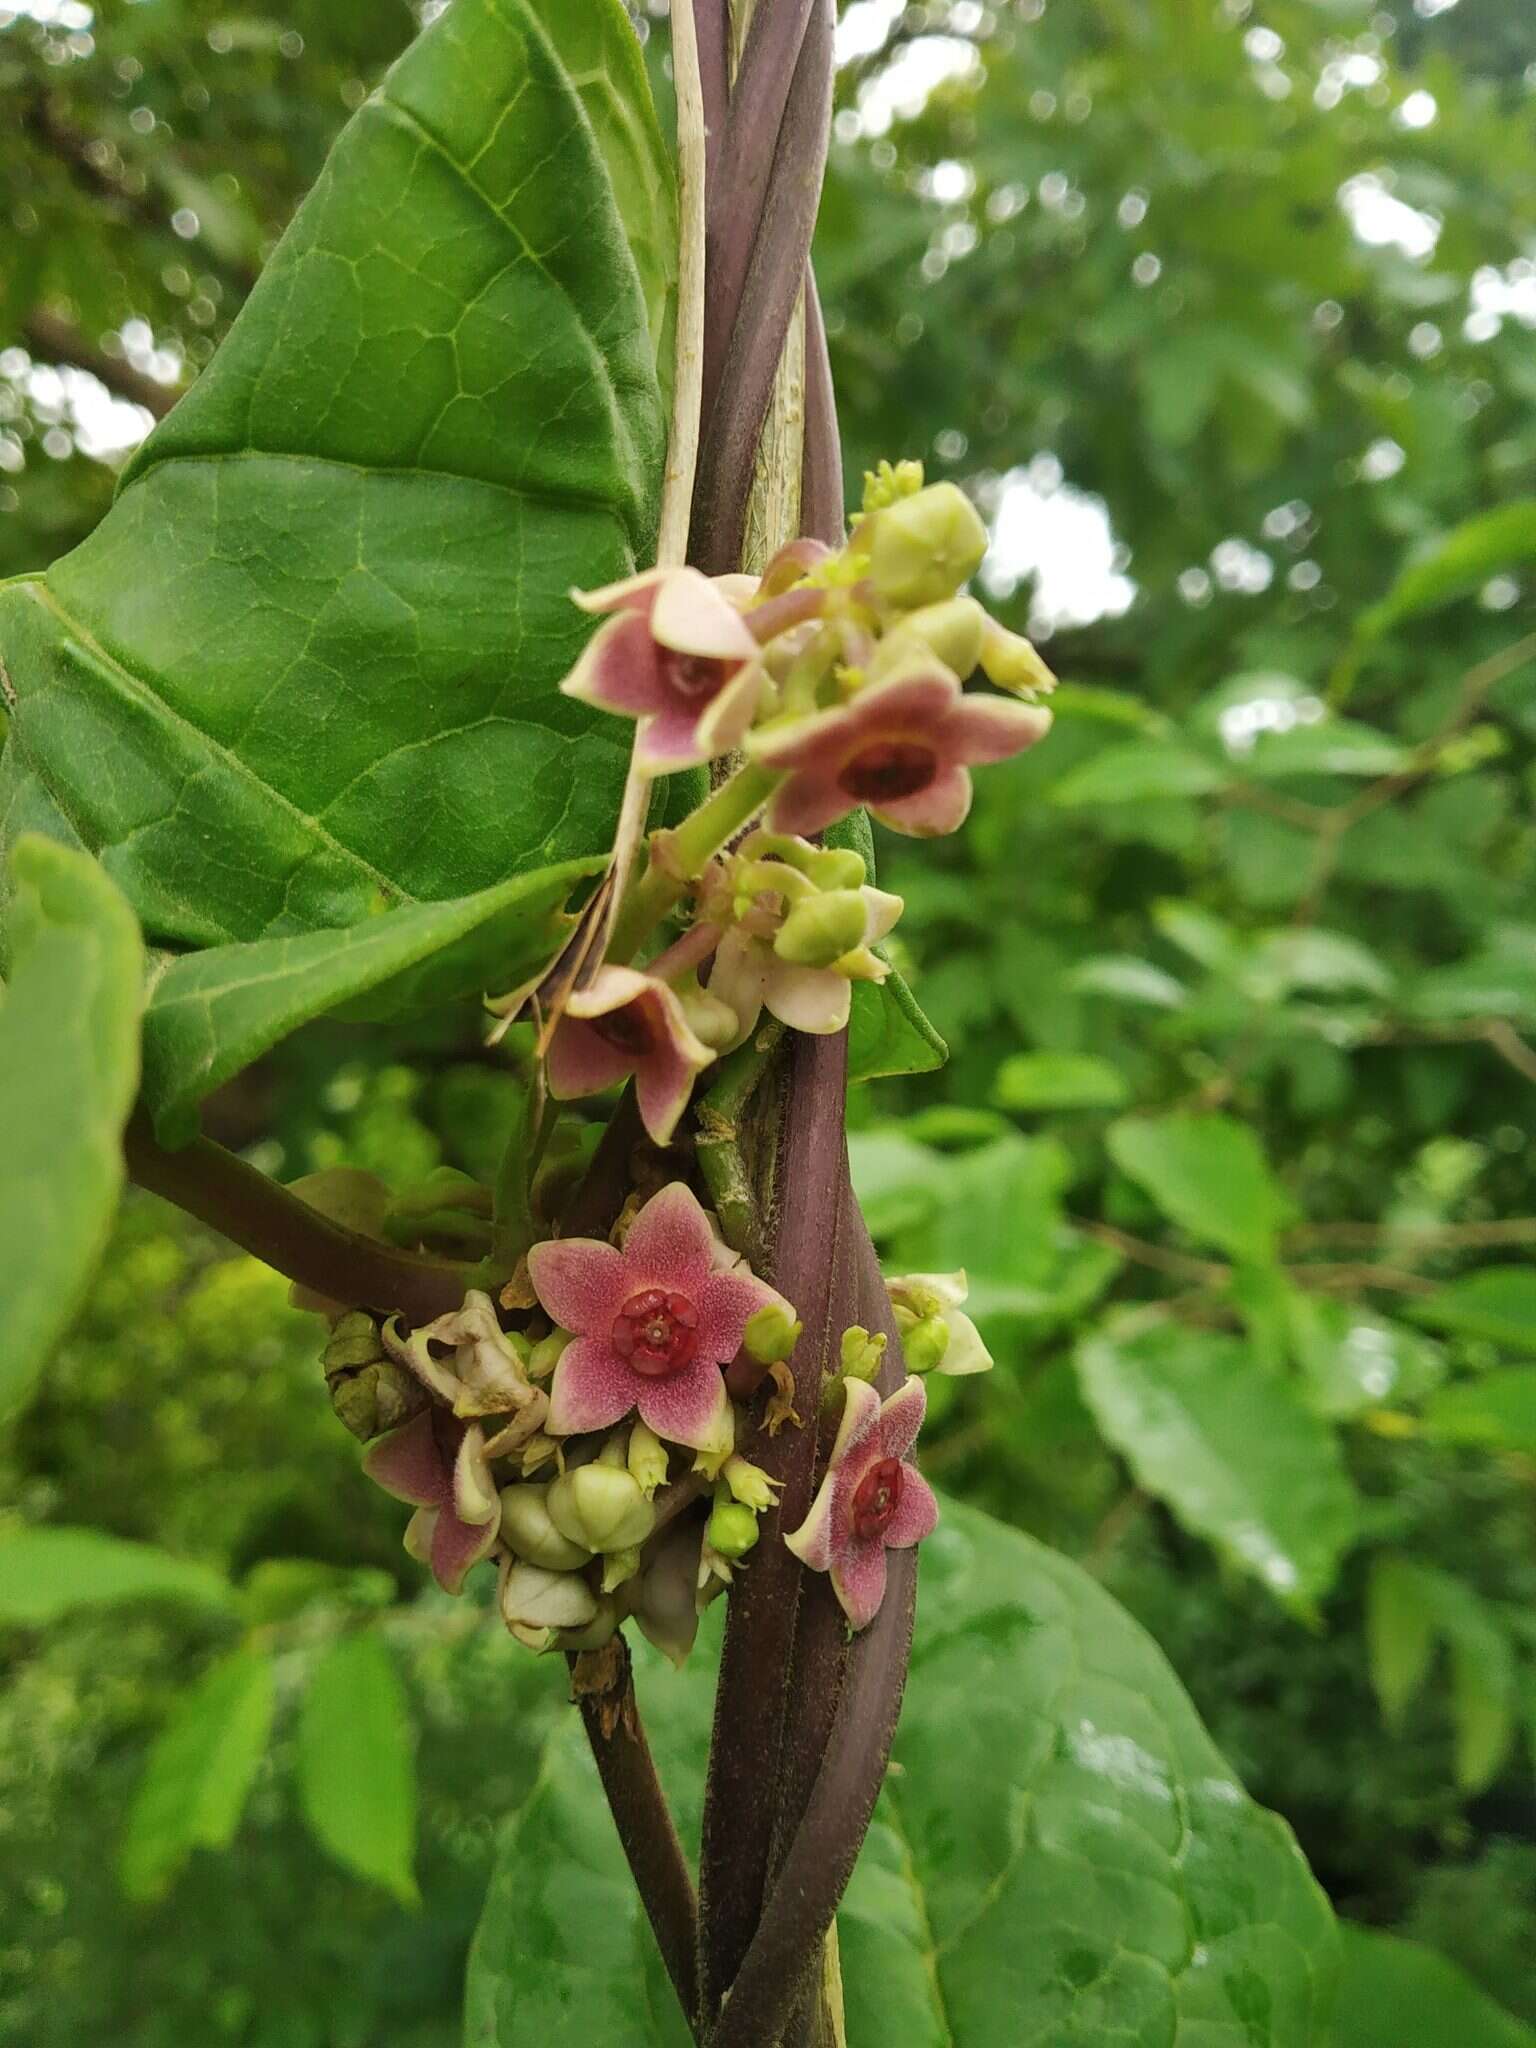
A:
[{"xmin": 1329, "ymin": 1923, "xmax": 1536, "ymax": 2048}]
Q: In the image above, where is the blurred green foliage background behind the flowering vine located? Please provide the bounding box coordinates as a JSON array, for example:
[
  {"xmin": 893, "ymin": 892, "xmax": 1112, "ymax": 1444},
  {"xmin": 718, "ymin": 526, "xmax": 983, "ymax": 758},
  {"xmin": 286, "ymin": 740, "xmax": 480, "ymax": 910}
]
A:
[{"xmin": 0, "ymin": 0, "xmax": 1536, "ymax": 2048}]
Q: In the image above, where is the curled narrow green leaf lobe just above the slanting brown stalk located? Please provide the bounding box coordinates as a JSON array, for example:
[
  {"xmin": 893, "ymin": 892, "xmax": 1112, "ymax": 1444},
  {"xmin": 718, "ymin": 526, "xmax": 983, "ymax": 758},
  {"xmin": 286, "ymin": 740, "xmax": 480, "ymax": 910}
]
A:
[{"xmin": 143, "ymin": 860, "xmax": 598, "ymax": 1145}]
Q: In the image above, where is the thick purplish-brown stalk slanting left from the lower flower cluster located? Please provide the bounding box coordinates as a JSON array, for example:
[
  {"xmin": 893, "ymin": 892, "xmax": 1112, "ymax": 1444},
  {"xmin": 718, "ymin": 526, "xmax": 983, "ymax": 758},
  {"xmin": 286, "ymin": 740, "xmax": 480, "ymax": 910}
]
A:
[{"xmin": 125, "ymin": 1110, "xmax": 479, "ymax": 1323}]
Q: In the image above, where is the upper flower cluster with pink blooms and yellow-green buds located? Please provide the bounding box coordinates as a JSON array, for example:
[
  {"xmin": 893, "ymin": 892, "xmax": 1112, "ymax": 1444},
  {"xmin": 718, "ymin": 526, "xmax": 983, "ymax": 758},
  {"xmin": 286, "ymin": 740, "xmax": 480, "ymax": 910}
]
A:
[{"xmin": 501, "ymin": 463, "xmax": 1053, "ymax": 1145}]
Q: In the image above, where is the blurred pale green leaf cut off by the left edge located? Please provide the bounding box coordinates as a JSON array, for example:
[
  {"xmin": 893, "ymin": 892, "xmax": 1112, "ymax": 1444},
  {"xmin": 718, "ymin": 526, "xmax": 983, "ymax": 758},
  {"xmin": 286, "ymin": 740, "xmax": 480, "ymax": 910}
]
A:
[{"xmin": 0, "ymin": 834, "xmax": 141, "ymax": 1421}]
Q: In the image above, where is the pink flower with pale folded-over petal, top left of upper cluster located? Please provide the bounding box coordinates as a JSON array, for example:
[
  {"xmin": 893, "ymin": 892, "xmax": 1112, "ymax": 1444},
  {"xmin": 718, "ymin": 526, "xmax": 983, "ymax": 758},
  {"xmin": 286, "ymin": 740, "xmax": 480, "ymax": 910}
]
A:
[{"xmin": 561, "ymin": 569, "xmax": 762, "ymax": 774}]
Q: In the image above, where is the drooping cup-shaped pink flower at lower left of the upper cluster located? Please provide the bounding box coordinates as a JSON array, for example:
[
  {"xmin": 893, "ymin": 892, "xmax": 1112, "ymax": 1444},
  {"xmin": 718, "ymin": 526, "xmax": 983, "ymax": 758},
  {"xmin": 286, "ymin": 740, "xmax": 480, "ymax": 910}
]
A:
[{"xmin": 549, "ymin": 967, "xmax": 715, "ymax": 1145}]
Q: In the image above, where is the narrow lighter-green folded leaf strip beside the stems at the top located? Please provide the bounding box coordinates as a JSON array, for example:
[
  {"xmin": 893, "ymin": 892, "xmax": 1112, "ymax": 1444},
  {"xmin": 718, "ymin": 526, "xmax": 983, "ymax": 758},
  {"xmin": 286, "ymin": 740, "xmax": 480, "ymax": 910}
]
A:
[{"xmin": 539, "ymin": 0, "xmax": 678, "ymax": 391}]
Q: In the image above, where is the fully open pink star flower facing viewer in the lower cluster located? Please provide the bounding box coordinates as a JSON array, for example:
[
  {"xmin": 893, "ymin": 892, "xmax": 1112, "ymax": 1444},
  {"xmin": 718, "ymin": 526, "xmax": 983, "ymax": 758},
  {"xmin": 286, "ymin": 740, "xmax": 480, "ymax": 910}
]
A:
[{"xmin": 528, "ymin": 1180, "xmax": 778, "ymax": 1450}]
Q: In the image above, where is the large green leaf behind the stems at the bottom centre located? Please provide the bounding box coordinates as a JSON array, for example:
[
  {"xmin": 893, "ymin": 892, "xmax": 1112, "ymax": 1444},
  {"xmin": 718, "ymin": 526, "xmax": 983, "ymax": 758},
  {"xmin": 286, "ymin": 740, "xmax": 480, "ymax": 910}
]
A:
[{"xmin": 465, "ymin": 1503, "xmax": 1335, "ymax": 2048}]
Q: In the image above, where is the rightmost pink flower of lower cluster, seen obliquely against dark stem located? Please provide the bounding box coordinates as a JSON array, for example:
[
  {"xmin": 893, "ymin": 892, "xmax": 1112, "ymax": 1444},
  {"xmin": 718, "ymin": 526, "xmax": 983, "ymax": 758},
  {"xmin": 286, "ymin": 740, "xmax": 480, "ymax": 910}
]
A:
[{"xmin": 784, "ymin": 1380, "xmax": 938, "ymax": 1628}]
